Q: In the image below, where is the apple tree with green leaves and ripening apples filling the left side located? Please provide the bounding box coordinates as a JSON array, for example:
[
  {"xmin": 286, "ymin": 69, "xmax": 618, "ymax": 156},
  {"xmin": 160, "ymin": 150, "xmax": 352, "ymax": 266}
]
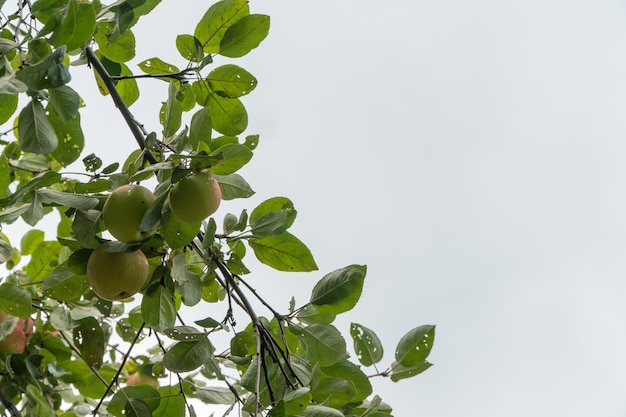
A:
[{"xmin": 0, "ymin": 0, "xmax": 435, "ymax": 417}]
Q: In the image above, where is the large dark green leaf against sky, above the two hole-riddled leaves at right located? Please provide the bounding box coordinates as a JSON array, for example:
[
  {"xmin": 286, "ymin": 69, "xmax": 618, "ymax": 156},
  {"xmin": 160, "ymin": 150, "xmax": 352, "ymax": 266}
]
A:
[{"xmin": 310, "ymin": 265, "xmax": 367, "ymax": 314}]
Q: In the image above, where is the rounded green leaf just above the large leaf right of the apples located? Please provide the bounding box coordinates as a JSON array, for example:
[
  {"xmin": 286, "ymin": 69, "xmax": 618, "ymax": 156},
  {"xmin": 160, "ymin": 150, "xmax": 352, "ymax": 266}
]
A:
[{"xmin": 249, "ymin": 197, "xmax": 298, "ymax": 237}]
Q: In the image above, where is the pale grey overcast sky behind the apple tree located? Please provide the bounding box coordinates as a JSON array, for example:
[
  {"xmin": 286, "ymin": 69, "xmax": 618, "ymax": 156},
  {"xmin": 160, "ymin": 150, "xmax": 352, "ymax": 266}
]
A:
[{"xmin": 6, "ymin": 0, "xmax": 626, "ymax": 417}]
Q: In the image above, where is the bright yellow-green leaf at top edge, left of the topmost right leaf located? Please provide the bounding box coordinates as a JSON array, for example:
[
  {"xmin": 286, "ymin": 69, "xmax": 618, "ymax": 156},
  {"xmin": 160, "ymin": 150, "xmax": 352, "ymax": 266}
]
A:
[{"xmin": 194, "ymin": 0, "xmax": 250, "ymax": 54}]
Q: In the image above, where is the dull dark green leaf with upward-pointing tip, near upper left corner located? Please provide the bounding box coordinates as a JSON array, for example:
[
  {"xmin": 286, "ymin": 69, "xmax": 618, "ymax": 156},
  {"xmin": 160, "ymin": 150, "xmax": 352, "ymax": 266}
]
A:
[{"xmin": 16, "ymin": 46, "xmax": 72, "ymax": 93}]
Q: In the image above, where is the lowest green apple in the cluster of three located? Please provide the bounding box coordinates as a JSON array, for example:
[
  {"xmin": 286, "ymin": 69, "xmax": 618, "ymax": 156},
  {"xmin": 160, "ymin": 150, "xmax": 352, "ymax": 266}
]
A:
[{"xmin": 87, "ymin": 242, "xmax": 150, "ymax": 301}]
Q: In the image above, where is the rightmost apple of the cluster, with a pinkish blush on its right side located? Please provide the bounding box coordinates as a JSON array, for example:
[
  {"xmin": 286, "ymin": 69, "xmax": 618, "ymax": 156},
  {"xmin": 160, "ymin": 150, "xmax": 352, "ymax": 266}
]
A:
[{"xmin": 168, "ymin": 172, "xmax": 222, "ymax": 223}]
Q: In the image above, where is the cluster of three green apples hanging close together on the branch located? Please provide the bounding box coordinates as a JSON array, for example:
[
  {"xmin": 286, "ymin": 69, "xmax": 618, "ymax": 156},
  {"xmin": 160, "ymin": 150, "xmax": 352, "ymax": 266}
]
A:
[{"xmin": 87, "ymin": 172, "xmax": 222, "ymax": 301}]
